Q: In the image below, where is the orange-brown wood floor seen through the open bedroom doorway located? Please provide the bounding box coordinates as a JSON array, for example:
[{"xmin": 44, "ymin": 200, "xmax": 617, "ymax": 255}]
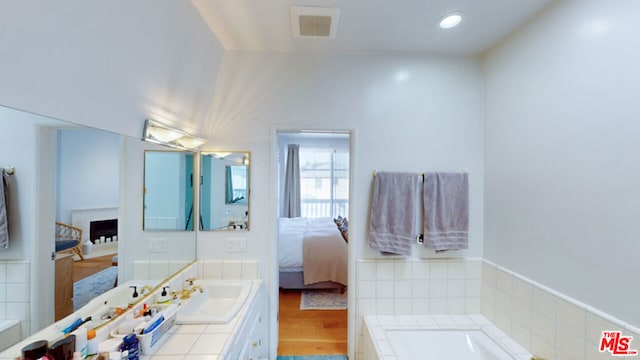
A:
[{"xmin": 278, "ymin": 290, "xmax": 347, "ymax": 355}]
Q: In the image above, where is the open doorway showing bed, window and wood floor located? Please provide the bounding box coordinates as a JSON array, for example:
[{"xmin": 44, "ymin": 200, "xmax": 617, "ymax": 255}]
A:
[{"xmin": 276, "ymin": 131, "xmax": 351, "ymax": 355}]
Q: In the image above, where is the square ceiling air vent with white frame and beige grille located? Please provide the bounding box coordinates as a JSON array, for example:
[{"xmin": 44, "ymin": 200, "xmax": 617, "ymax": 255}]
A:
[{"xmin": 291, "ymin": 6, "xmax": 340, "ymax": 38}]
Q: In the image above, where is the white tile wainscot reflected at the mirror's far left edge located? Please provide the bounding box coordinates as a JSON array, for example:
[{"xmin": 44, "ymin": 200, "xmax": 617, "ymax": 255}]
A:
[{"xmin": 0, "ymin": 261, "xmax": 31, "ymax": 338}]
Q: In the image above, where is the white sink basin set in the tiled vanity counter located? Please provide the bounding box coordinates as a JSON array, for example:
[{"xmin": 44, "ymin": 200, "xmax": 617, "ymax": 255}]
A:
[{"xmin": 176, "ymin": 280, "xmax": 252, "ymax": 324}]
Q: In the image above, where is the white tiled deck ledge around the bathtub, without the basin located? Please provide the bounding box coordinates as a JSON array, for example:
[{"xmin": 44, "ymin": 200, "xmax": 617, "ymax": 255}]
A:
[{"xmin": 359, "ymin": 314, "xmax": 531, "ymax": 360}]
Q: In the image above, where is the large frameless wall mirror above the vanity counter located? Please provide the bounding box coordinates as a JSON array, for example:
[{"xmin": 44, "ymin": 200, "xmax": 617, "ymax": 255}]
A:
[{"xmin": 0, "ymin": 106, "xmax": 196, "ymax": 352}]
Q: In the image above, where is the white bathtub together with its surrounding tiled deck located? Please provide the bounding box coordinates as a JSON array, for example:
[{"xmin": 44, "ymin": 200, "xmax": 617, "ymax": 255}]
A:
[{"xmin": 358, "ymin": 314, "xmax": 531, "ymax": 360}]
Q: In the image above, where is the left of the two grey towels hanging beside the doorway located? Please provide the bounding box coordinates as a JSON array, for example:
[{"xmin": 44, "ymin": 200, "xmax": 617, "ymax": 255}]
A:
[{"xmin": 369, "ymin": 172, "xmax": 419, "ymax": 255}]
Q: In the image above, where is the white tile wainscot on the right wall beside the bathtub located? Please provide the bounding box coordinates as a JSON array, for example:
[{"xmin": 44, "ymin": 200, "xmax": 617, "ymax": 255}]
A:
[{"xmin": 482, "ymin": 261, "xmax": 640, "ymax": 360}]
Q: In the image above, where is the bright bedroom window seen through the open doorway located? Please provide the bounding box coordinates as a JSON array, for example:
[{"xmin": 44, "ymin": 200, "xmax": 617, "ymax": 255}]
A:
[{"xmin": 300, "ymin": 145, "xmax": 349, "ymax": 218}]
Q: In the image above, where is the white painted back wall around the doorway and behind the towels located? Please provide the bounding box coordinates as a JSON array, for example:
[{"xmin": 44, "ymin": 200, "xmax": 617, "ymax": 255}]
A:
[{"xmin": 197, "ymin": 51, "xmax": 484, "ymax": 358}]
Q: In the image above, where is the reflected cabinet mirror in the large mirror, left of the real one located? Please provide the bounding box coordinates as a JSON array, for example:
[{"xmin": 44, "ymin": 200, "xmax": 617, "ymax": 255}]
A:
[{"xmin": 142, "ymin": 150, "xmax": 194, "ymax": 231}]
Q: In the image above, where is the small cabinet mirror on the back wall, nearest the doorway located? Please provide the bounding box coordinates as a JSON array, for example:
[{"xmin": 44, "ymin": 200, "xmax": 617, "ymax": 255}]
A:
[{"xmin": 200, "ymin": 151, "xmax": 251, "ymax": 230}]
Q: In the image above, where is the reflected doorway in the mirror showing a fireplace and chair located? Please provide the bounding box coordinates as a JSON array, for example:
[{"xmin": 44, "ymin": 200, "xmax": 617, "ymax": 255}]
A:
[{"xmin": 54, "ymin": 128, "xmax": 122, "ymax": 320}]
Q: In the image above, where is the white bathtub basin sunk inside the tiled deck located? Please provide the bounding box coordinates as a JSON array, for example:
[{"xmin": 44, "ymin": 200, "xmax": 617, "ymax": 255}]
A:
[{"xmin": 387, "ymin": 330, "xmax": 513, "ymax": 360}]
